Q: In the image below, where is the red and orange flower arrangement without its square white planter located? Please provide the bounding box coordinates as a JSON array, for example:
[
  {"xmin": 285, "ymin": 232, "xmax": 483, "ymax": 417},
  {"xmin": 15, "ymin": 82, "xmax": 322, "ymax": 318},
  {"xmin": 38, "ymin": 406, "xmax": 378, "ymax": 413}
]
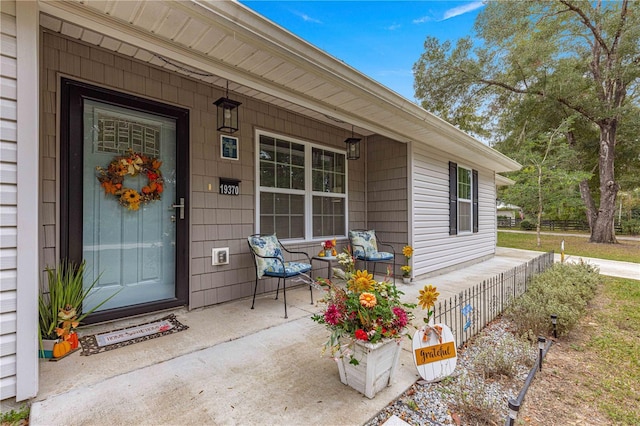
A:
[{"xmin": 311, "ymin": 250, "xmax": 416, "ymax": 363}]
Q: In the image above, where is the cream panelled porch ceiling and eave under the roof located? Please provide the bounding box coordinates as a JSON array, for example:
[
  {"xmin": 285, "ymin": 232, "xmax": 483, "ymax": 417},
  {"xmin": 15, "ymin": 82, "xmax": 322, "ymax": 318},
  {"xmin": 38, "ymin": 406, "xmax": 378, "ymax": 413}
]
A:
[{"xmin": 39, "ymin": 0, "xmax": 520, "ymax": 172}]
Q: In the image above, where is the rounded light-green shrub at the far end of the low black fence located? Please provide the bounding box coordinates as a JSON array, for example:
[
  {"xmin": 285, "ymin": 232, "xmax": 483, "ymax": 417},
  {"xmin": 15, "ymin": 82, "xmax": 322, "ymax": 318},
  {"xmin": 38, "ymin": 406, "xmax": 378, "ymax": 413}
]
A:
[{"xmin": 506, "ymin": 262, "xmax": 599, "ymax": 337}]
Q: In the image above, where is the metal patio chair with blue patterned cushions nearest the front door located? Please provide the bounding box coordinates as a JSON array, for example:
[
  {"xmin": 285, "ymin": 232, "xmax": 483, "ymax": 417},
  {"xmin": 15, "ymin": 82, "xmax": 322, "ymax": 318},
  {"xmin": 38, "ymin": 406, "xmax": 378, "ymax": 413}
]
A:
[{"xmin": 247, "ymin": 234, "xmax": 313, "ymax": 318}]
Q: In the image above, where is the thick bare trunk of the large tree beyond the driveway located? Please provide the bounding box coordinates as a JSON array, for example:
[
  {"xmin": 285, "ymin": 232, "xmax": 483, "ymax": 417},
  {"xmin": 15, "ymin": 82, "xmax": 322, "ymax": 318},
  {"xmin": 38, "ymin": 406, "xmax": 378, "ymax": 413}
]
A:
[{"xmin": 589, "ymin": 119, "xmax": 619, "ymax": 244}]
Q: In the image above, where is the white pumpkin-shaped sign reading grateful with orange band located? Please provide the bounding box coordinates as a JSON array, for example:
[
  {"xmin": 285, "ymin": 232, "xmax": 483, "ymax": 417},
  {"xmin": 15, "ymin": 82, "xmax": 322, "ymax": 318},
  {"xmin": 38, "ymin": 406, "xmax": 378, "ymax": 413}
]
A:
[{"xmin": 413, "ymin": 324, "xmax": 458, "ymax": 382}]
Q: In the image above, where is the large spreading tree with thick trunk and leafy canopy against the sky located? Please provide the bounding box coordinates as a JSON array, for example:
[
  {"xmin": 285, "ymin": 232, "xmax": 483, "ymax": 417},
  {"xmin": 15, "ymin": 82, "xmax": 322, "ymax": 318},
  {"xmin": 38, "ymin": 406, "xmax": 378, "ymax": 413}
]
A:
[{"xmin": 414, "ymin": 0, "xmax": 640, "ymax": 243}]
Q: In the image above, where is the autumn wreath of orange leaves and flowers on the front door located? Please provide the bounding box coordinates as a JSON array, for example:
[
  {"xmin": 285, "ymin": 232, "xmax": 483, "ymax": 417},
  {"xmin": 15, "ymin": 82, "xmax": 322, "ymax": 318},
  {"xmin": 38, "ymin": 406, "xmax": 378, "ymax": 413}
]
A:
[{"xmin": 96, "ymin": 151, "xmax": 164, "ymax": 210}]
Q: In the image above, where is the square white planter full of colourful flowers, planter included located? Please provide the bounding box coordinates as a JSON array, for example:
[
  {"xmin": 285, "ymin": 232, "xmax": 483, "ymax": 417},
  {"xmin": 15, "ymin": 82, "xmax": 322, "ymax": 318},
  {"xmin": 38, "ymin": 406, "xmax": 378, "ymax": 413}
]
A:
[{"xmin": 312, "ymin": 248, "xmax": 416, "ymax": 398}]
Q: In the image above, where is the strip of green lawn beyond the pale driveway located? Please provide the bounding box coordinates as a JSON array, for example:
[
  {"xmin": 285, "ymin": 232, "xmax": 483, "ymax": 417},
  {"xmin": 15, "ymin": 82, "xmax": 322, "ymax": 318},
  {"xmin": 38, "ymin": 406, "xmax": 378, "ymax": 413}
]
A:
[{"xmin": 498, "ymin": 231, "xmax": 640, "ymax": 263}]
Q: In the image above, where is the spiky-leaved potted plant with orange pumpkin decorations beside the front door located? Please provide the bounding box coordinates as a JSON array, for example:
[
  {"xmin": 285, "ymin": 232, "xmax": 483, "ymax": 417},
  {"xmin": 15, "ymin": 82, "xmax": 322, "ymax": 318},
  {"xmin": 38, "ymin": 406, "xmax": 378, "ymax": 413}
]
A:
[{"xmin": 38, "ymin": 260, "xmax": 118, "ymax": 358}]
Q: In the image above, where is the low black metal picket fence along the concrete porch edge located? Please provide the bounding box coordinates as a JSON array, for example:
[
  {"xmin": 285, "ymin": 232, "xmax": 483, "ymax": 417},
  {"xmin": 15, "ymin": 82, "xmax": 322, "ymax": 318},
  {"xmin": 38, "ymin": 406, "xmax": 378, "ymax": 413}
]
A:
[{"xmin": 434, "ymin": 251, "xmax": 554, "ymax": 347}]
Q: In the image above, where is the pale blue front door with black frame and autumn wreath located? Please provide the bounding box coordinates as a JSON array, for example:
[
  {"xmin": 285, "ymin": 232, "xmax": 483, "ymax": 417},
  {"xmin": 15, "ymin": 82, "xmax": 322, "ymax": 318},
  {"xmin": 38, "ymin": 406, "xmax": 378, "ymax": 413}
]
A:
[{"xmin": 60, "ymin": 79, "xmax": 189, "ymax": 323}]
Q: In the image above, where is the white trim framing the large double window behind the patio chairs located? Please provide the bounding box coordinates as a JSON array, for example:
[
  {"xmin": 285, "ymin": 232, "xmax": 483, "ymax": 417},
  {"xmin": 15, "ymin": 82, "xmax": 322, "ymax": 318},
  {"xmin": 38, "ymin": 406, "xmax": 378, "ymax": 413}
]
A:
[{"xmin": 254, "ymin": 129, "xmax": 349, "ymax": 242}]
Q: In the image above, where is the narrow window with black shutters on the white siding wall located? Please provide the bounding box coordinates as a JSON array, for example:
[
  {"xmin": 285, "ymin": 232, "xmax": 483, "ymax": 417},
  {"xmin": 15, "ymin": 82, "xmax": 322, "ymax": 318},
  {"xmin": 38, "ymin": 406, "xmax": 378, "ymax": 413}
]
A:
[{"xmin": 449, "ymin": 162, "xmax": 478, "ymax": 235}]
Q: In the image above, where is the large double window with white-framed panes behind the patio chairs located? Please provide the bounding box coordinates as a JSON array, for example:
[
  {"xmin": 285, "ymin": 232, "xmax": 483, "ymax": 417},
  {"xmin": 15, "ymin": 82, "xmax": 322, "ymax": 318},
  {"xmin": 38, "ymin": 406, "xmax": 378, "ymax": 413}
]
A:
[{"xmin": 257, "ymin": 132, "xmax": 347, "ymax": 240}]
